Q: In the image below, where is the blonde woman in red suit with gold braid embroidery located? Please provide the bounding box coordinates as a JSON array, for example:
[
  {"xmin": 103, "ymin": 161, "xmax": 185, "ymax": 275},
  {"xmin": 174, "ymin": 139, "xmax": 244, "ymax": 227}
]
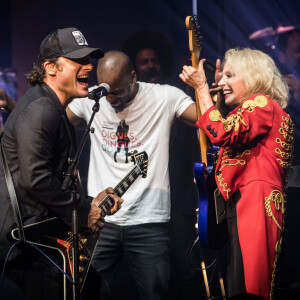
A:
[{"xmin": 179, "ymin": 48, "xmax": 293, "ymax": 298}]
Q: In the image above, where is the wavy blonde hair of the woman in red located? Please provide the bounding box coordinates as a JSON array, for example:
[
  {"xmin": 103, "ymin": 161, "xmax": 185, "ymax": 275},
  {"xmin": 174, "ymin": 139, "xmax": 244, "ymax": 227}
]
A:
[{"xmin": 222, "ymin": 48, "xmax": 289, "ymax": 108}]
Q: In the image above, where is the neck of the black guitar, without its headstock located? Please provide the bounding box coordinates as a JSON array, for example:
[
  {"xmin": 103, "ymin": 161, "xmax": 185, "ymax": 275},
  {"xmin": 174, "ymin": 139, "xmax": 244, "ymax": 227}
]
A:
[{"xmin": 98, "ymin": 166, "xmax": 142, "ymax": 214}]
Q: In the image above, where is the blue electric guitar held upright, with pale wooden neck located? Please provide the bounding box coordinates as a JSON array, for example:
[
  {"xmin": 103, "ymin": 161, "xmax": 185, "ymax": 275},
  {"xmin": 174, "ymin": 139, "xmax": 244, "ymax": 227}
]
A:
[{"xmin": 185, "ymin": 16, "xmax": 223, "ymax": 248}]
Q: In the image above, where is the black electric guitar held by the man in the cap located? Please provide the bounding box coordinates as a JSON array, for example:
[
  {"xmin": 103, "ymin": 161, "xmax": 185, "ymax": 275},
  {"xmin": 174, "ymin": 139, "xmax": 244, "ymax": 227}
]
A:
[{"xmin": 11, "ymin": 151, "xmax": 148, "ymax": 290}]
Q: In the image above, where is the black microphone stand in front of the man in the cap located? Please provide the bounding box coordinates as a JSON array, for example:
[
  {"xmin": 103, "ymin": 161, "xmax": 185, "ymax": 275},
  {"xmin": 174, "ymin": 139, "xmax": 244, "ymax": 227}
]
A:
[{"xmin": 62, "ymin": 93, "xmax": 103, "ymax": 300}]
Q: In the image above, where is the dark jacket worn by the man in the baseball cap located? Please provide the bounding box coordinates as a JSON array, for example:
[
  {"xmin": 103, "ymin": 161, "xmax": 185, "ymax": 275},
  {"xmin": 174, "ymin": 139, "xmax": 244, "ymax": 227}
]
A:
[{"xmin": 0, "ymin": 84, "xmax": 92, "ymax": 259}]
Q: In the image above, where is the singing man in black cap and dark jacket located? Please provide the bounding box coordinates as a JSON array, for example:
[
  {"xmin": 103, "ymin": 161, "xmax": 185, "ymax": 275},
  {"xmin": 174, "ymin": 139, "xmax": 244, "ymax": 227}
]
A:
[{"xmin": 0, "ymin": 28, "xmax": 122, "ymax": 299}]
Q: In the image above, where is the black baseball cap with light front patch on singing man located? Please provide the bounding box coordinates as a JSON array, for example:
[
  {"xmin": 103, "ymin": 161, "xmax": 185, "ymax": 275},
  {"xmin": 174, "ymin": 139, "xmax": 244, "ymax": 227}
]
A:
[{"xmin": 39, "ymin": 27, "xmax": 104, "ymax": 61}]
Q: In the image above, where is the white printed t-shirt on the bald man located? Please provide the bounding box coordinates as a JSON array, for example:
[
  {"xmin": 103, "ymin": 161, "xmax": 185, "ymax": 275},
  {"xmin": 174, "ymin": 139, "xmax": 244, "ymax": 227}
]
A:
[{"xmin": 69, "ymin": 82, "xmax": 194, "ymax": 225}]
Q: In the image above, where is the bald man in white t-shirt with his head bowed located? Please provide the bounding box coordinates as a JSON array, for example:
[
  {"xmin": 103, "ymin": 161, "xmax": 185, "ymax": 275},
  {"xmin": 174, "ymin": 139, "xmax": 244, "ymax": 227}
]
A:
[{"xmin": 67, "ymin": 51, "xmax": 197, "ymax": 299}]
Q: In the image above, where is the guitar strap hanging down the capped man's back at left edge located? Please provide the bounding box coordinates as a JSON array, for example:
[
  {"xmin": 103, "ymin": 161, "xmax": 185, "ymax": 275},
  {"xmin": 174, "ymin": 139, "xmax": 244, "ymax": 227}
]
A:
[{"xmin": 0, "ymin": 132, "xmax": 26, "ymax": 243}]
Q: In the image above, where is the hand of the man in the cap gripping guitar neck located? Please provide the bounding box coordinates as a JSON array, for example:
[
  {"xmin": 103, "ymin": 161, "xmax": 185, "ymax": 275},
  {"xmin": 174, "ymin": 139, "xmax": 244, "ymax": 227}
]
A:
[{"xmin": 88, "ymin": 187, "xmax": 123, "ymax": 231}]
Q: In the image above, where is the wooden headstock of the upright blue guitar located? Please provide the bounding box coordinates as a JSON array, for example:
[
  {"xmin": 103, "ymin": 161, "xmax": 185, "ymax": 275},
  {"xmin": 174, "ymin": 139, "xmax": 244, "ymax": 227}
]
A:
[{"xmin": 185, "ymin": 16, "xmax": 202, "ymax": 60}]
